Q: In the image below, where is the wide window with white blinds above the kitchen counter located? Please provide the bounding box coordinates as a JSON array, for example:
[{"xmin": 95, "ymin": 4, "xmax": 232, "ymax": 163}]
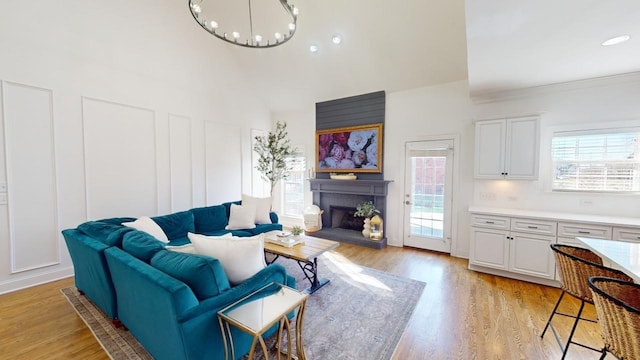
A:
[{"xmin": 551, "ymin": 128, "xmax": 640, "ymax": 192}]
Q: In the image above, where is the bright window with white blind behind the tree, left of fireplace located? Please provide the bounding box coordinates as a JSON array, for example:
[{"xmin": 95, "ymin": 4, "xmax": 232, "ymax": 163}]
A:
[{"xmin": 282, "ymin": 152, "xmax": 306, "ymax": 218}]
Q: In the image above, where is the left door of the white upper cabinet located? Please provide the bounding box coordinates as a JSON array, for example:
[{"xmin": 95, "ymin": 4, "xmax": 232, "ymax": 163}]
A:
[{"xmin": 475, "ymin": 120, "xmax": 507, "ymax": 179}]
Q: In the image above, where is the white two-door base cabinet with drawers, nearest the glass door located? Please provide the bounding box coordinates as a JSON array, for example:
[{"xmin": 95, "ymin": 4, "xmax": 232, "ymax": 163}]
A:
[{"xmin": 469, "ymin": 214, "xmax": 556, "ymax": 279}]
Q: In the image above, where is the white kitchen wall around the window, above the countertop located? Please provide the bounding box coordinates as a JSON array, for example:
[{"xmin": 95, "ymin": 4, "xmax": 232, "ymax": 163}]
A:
[{"xmin": 473, "ymin": 74, "xmax": 640, "ymax": 217}]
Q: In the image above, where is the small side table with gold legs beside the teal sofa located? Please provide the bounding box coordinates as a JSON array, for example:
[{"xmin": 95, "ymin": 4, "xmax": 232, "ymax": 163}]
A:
[{"xmin": 218, "ymin": 283, "xmax": 309, "ymax": 360}]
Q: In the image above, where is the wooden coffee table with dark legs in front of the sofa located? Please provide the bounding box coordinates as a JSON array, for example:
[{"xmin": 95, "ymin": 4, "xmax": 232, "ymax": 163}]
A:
[{"xmin": 264, "ymin": 231, "xmax": 340, "ymax": 294}]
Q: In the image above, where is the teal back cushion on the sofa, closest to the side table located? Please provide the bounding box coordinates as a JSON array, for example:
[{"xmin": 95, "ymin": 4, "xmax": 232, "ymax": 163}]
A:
[{"xmin": 151, "ymin": 250, "xmax": 231, "ymax": 301}]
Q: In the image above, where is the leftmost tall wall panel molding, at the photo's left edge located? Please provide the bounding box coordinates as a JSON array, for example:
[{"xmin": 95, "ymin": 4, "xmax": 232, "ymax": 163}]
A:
[{"xmin": 2, "ymin": 81, "xmax": 61, "ymax": 274}]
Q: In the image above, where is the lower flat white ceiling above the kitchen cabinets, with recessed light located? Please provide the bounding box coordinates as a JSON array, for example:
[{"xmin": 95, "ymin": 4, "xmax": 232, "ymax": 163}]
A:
[{"xmin": 466, "ymin": 0, "xmax": 640, "ymax": 96}]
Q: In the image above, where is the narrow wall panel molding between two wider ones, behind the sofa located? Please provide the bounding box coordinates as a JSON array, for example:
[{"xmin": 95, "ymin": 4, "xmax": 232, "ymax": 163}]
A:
[{"xmin": 169, "ymin": 113, "xmax": 195, "ymax": 212}]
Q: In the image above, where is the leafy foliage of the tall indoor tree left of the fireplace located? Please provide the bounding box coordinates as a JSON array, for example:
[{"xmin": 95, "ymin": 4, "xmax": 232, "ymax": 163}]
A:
[{"xmin": 253, "ymin": 121, "xmax": 295, "ymax": 196}]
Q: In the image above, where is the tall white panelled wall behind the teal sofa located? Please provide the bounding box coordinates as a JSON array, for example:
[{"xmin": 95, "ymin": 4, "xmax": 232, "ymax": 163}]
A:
[{"xmin": 0, "ymin": 0, "xmax": 271, "ymax": 293}]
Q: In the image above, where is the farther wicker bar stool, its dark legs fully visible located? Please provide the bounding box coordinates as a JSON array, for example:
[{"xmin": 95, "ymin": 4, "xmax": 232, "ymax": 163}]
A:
[{"xmin": 540, "ymin": 244, "xmax": 633, "ymax": 359}]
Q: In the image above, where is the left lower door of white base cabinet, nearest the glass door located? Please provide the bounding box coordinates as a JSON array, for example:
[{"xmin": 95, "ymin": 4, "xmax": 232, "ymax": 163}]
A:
[{"xmin": 469, "ymin": 227, "xmax": 509, "ymax": 270}]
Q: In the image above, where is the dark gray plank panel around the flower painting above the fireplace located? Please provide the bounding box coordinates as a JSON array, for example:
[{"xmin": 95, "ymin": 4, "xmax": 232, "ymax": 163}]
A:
[{"xmin": 315, "ymin": 91, "xmax": 386, "ymax": 180}]
